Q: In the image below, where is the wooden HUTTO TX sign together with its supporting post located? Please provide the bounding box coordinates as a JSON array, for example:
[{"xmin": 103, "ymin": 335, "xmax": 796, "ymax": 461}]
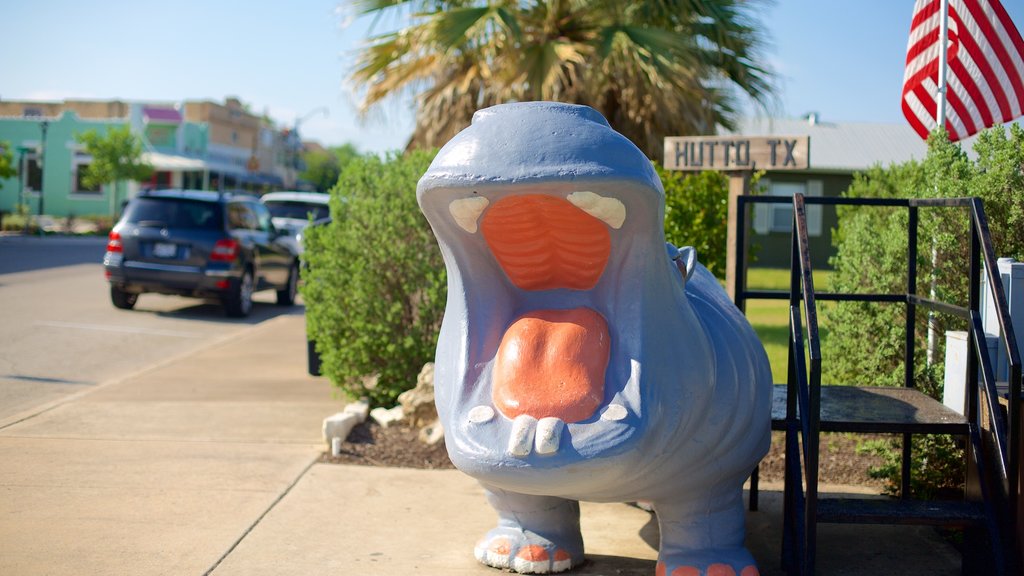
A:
[{"xmin": 665, "ymin": 135, "xmax": 811, "ymax": 301}]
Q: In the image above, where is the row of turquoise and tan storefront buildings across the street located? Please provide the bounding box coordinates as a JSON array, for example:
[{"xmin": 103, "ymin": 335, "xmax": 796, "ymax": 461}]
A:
[{"xmin": 0, "ymin": 97, "xmax": 299, "ymax": 218}]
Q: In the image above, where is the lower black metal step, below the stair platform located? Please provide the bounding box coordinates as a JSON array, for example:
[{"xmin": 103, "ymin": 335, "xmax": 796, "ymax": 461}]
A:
[{"xmin": 818, "ymin": 498, "xmax": 985, "ymax": 527}]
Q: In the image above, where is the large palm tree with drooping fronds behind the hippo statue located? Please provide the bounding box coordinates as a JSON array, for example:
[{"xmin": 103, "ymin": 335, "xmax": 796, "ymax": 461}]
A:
[{"xmin": 352, "ymin": 0, "xmax": 771, "ymax": 158}]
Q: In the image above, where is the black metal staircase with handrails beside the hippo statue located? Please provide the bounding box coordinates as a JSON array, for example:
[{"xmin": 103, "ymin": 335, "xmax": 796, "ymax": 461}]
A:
[{"xmin": 733, "ymin": 195, "xmax": 1021, "ymax": 575}]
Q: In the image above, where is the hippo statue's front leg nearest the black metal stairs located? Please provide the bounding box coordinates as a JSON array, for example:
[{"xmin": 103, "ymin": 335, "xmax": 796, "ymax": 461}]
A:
[{"xmin": 654, "ymin": 488, "xmax": 758, "ymax": 576}]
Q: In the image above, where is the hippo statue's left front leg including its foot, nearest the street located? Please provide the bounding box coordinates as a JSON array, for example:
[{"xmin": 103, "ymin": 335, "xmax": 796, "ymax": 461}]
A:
[{"xmin": 473, "ymin": 485, "xmax": 584, "ymax": 574}]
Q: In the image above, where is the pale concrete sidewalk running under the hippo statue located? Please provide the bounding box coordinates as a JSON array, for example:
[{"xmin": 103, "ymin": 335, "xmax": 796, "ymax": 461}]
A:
[{"xmin": 0, "ymin": 316, "xmax": 959, "ymax": 576}]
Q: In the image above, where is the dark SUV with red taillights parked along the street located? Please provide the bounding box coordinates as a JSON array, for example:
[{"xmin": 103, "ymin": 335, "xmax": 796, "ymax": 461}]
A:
[{"xmin": 103, "ymin": 190, "xmax": 299, "ymax": 317}]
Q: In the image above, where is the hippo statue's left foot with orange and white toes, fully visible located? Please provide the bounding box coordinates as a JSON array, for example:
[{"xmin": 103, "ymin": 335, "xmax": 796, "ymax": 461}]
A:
[{"xmin": 473, "ymin": 528, "xmax": 583, "ymax": 574}]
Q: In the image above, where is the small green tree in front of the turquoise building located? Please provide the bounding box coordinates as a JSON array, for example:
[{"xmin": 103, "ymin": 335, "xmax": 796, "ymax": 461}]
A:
[{"xmin": 75, "ymin": 126, "xmax": 153, "ymax": 215}]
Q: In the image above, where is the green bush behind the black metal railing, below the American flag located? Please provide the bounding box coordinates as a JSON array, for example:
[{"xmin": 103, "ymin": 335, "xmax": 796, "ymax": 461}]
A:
[{"xmin": 820, "ymin": 125, "xmax": 1024, "ymax": 497}]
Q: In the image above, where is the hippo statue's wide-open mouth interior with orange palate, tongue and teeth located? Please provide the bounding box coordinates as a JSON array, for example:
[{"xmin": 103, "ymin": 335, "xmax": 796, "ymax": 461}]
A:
[{"xmin": 436, "ymin": 186, "xmax": 668, "ymax": 460}]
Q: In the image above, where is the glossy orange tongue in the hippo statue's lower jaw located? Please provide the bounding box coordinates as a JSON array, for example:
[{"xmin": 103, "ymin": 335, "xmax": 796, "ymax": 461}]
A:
[{"xmin": 492, "ymin": 307, "xmax": 609, "ymax": 423}]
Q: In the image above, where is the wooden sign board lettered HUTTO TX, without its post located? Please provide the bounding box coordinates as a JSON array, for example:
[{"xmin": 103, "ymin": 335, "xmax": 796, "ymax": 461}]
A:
[{"xmin": 665, "ymin": 136, "xmax": 811, "ymax": 171}]
